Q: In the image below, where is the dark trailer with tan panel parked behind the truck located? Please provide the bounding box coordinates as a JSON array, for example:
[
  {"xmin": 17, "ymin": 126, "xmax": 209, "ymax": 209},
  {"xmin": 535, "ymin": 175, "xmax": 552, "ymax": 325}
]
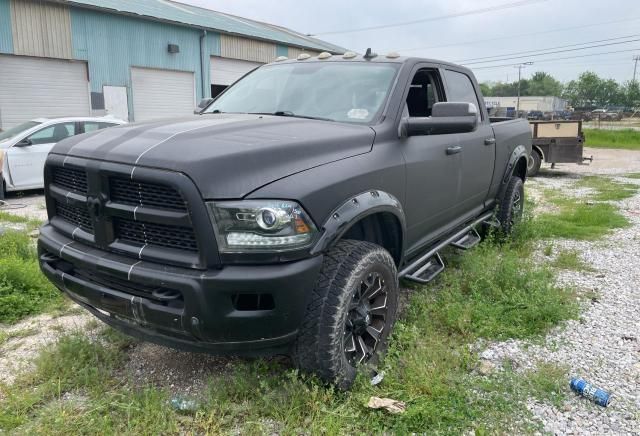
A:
[{"xmin": 527, "ymin": 120, "xmax": 593, "ymax": 176}]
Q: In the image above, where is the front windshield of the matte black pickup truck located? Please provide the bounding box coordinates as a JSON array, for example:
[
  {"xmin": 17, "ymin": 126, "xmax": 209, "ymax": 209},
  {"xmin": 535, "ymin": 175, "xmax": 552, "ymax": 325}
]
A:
[{"xmin": 204, "ymin": 62, "xmax": 398, "ymax": 123}]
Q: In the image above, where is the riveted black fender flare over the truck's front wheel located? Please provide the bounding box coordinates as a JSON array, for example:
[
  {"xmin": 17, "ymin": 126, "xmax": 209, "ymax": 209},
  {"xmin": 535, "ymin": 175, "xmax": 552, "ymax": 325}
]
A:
[{"xmin": 310, "ymin": 189, "xmax": 407, "ymax": 255}]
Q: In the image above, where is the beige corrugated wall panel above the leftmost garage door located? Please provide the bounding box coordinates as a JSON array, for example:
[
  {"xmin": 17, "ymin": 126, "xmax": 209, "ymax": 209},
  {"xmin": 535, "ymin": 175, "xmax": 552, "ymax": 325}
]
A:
[{"xmin": 11, "ymin": 0, "xmax": 72, "ymax": 59}]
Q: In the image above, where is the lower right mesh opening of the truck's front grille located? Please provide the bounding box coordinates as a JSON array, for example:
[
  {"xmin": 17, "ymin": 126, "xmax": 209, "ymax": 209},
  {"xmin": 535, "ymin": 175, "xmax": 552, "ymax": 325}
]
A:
[{"xmin": 114, "ymin": 218, "xmax": 198, "ymax": 252}]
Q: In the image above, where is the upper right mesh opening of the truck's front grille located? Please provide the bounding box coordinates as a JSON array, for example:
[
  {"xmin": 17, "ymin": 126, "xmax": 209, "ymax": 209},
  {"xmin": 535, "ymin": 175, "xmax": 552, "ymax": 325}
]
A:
[{"xmin": 109, "ymin": 177, "xmax": 187, "ymax": 211}]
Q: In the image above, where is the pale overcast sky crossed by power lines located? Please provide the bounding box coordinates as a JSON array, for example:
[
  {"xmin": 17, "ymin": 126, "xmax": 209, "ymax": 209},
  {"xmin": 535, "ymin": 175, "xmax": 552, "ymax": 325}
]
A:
[{"xmin": 179, "ymin": 0, "xmax": 640, "ymax": 82}]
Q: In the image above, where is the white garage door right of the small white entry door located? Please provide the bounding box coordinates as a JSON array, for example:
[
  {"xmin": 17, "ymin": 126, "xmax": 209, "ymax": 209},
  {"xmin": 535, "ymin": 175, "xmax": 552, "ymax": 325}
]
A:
[{"xmin": 131, "ymin": 68, "xmax": 196, "ymax": 121}]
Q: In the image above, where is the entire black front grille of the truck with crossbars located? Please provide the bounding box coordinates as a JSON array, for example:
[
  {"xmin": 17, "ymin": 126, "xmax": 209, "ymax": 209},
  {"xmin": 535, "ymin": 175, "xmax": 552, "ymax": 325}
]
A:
[{"xmin": 45, "ymin": 161, "xmax": 210, "ymax": 268}]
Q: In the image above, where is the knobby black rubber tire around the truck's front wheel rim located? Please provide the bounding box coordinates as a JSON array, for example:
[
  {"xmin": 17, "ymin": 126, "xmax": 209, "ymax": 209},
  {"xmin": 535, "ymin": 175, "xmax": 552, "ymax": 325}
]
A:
[{"xmin": 293, "ymin": 240, "xmax": 399, "ymax": 390}]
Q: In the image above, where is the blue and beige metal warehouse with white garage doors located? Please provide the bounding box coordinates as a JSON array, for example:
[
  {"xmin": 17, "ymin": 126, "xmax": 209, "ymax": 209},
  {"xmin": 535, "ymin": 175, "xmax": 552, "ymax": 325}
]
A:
[{"xmin": 0, "ymin": 0, "xmax": 345, "ymax": 129}]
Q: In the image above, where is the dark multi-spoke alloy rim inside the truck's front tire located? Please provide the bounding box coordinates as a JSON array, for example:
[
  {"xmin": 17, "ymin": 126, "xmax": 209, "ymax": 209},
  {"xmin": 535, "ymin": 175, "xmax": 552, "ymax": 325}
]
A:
[{"xmin": 344, "ymin": 271, "xmax": 388, "ymax": 367}]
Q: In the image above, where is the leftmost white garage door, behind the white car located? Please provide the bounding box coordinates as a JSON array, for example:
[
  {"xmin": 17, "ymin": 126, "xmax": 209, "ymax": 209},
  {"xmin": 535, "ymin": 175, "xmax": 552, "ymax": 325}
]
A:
[{"xmin": 0, "ymin": 55, "xmax": 90, "ymax": 130}]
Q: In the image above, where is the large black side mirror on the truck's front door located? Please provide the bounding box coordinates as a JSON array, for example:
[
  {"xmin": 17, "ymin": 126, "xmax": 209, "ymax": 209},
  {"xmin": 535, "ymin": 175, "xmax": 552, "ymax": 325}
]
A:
[{"xmin": 401, "ymin": 102, "xmax": 478, "ymax": 136}]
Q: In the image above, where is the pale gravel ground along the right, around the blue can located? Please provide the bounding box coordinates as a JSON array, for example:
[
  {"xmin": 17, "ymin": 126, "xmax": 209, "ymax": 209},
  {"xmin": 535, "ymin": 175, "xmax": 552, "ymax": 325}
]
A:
[{"xmin": 481, "ymin": 153, "xmax": 640, "ymax": 434}]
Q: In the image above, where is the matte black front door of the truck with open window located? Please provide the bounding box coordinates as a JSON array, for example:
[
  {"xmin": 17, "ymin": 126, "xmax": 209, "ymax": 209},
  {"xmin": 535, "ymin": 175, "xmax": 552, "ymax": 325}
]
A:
[{"xmin": 401, "ymin": 67, "xmax": 461, "ymax": 251}]
